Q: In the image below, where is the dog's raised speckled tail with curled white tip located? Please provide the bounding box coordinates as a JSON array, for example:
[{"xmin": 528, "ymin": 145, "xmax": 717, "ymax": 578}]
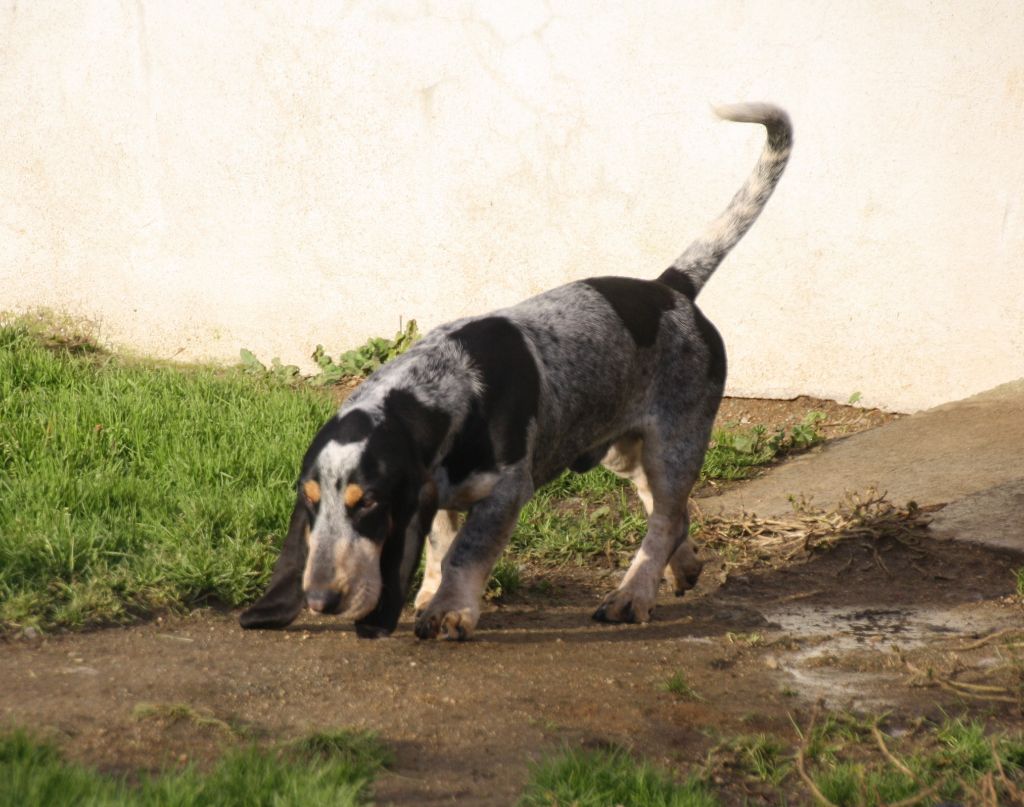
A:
[{"xmin": 658, "ymin": 103, "xmax": 793, "ymax": 300}]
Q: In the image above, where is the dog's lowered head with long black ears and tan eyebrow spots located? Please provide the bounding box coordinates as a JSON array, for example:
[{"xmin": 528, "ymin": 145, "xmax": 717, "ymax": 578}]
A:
[{"xmin": 241, "ymin": 391, "xmax": 446, "ymax": 636}]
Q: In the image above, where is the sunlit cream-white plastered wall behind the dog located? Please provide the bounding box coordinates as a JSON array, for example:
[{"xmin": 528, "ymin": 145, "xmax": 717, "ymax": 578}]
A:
[{"xmin": 0, "ymin": 0, "xmax": 1024, "ymax": 410}]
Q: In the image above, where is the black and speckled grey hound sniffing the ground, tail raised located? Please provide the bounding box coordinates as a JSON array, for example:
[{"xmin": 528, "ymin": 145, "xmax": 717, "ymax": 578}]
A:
[{"xmin": 241, "ymin": 104, "xmax": 792, "ymax": 639}]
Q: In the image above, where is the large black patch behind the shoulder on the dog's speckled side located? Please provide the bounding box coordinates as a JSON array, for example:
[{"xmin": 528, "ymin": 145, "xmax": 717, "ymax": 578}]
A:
[{"xmin": 451, "ymin": 316, "xmax": 541, "ymax": 466}]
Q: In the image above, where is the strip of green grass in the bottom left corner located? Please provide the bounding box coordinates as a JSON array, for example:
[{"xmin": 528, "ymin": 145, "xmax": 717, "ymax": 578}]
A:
[{"xmin": 0, "ymin": 730, "xmax": 390, "ymax": 807}]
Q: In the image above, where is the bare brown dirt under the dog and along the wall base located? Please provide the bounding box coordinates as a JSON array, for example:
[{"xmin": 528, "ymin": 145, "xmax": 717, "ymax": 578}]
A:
[{"xmin": 0, "ymin": 399, "xmax": 1022, "ymax": 805}]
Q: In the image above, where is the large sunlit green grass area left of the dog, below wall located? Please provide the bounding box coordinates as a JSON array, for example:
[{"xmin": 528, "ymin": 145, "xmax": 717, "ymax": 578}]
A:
[{"xmin": 0, "ymin": 326, "xmax": 334, "ymax": 629}]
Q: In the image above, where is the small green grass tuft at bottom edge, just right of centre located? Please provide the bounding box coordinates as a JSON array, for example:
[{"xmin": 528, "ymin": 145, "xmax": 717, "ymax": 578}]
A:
[{"xmin": 519, "ymin": 750, "xmax": 719, "ymax": 807}]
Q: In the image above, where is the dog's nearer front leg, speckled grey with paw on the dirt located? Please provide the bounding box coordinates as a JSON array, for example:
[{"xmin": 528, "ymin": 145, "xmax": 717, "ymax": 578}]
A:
[{"xmin": 416, "ymin": 472, "xmax": 532, "ymax": 639}]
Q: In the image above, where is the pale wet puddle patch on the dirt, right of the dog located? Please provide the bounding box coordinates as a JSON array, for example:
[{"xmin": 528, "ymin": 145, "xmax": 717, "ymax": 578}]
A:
[{"xmin": 764, "ymin": 604, "xmax": 991, "ymax": 709}]
